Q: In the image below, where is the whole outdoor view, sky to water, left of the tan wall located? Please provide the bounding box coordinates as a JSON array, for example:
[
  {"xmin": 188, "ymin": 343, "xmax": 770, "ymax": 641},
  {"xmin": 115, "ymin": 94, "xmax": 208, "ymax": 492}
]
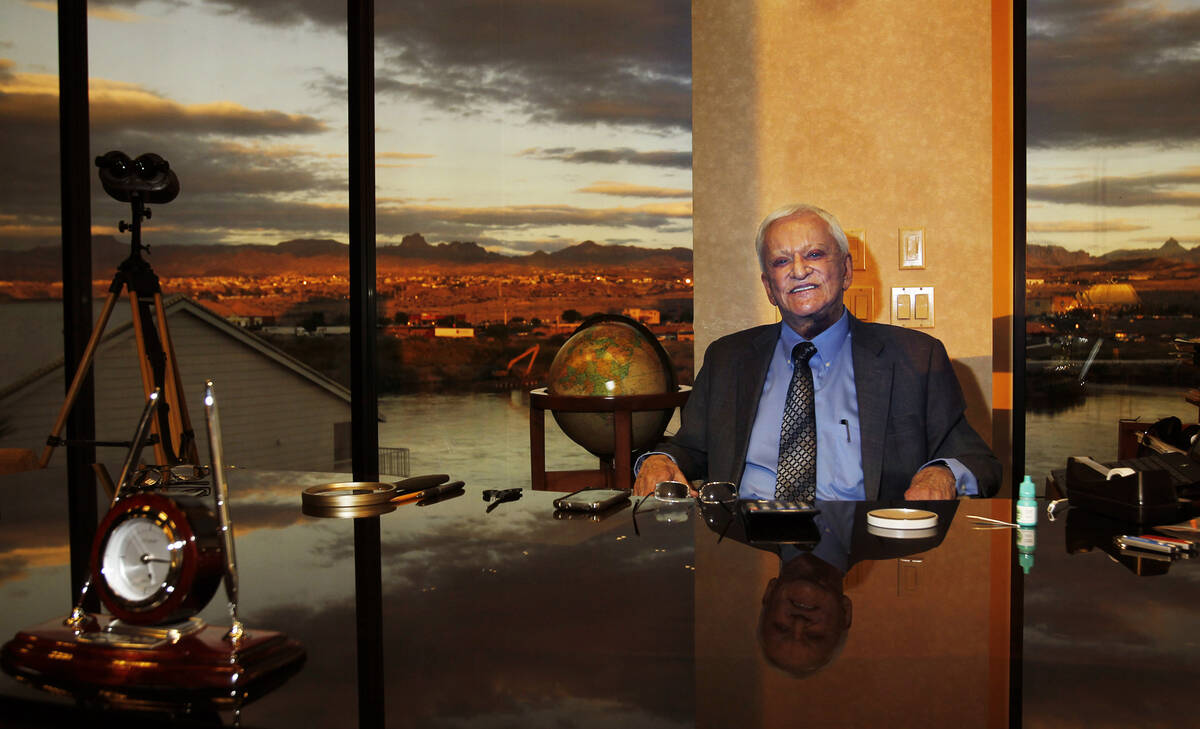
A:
[{"xmin": 0, "ymin": 0, "xmax": 692, "ymax": 486}]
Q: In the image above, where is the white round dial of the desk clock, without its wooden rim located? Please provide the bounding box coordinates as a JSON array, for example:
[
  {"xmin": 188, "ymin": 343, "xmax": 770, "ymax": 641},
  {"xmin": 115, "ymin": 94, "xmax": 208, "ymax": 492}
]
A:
[{"xmin": 102, "ymin": 513, "xmax": 181, "ymax": 603}]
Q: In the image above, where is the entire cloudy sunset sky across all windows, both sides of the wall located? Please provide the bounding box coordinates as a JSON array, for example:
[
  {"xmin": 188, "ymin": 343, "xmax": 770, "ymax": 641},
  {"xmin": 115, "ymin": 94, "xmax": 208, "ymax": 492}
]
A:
[{"xmin": 0, "ymin": 0, "xmax": 1200, "ymax": 258}]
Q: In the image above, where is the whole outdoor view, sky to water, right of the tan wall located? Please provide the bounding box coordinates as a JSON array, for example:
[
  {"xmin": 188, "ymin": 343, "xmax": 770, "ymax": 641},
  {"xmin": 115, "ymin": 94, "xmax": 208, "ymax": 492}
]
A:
[{"xmin": 1025, "ymin": 0, "xmax": 1200, "ymax": 477}]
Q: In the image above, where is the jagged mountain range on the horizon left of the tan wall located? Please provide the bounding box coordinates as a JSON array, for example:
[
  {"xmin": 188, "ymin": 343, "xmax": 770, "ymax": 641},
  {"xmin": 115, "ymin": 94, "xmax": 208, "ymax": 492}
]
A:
[{"xmin": 0, "ymin": 233, "xmax": 691, "ymax": 281}]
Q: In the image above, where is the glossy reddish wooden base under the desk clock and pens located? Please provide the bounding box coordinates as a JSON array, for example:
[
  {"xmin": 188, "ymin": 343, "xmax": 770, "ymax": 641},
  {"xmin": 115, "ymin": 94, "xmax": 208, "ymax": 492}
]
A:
[{"xmin": 0, "ymin": 615, "xmax": 305, "ymax": 707}]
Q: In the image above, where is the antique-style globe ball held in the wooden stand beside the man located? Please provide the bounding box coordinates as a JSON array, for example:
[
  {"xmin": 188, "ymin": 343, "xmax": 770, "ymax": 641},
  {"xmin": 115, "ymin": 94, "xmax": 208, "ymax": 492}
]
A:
[{"xmin": 546, "ymin": 314, "xmax": 676, "ymax": 457}]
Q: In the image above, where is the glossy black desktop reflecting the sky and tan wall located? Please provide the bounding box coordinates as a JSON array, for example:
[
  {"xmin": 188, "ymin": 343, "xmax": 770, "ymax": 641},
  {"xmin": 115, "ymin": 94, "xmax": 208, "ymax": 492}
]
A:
[{"xmin": 0, "ymin": 471, "xmax": 1200, "ymax": 728}]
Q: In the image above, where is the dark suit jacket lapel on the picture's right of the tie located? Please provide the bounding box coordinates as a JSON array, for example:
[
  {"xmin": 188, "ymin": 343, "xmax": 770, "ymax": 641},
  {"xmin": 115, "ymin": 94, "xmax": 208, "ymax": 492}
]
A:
[{"xmin": 851, "ymin": 319, "xmax": 892, "ymax": 501}]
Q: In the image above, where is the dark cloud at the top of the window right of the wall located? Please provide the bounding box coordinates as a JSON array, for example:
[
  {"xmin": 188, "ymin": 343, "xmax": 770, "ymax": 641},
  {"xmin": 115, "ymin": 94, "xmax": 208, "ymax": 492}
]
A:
[{"xmin": 1026, "ymin": 0, "xmax": 1200, "ymax": 147}]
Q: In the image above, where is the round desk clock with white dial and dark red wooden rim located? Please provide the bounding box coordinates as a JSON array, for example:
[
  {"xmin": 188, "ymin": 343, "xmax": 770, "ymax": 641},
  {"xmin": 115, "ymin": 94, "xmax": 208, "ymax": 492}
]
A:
[{"xmin": 91, "ymin": 492, "xmax": 224, "ymax": 625}]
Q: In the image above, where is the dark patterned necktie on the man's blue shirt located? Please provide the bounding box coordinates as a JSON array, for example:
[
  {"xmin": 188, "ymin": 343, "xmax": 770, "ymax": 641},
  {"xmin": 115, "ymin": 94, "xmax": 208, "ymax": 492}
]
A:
[{"xmin": 775, "ymin": 342, "xmax": 817, "ymax": 502}]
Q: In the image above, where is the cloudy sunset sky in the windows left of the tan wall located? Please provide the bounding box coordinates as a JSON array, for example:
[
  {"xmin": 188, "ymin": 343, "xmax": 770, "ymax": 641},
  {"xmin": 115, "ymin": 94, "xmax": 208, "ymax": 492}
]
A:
[{"xmin": 0, "ymin": 0, "xmax": 691, "ymax": 253}]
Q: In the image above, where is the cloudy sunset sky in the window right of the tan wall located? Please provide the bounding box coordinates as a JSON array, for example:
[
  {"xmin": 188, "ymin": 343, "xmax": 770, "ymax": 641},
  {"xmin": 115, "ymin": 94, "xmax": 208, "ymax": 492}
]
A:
[{"xmin": 1026, "ymin": 0, "xmax": 1200, "ymax": 254}]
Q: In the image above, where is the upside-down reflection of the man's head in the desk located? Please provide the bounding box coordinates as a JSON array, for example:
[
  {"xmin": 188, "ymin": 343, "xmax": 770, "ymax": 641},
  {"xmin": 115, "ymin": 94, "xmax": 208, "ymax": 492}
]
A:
[{"xmin": 758, "ymin": 554, "xmax": 852, "ymax": 677}]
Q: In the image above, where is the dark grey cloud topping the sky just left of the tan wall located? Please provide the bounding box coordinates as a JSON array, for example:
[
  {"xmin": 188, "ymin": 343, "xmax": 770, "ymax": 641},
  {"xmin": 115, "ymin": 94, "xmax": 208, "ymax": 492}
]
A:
[{"xmin": 200, "ymin": 0, "xmax": 691, "ymax": 131}]
